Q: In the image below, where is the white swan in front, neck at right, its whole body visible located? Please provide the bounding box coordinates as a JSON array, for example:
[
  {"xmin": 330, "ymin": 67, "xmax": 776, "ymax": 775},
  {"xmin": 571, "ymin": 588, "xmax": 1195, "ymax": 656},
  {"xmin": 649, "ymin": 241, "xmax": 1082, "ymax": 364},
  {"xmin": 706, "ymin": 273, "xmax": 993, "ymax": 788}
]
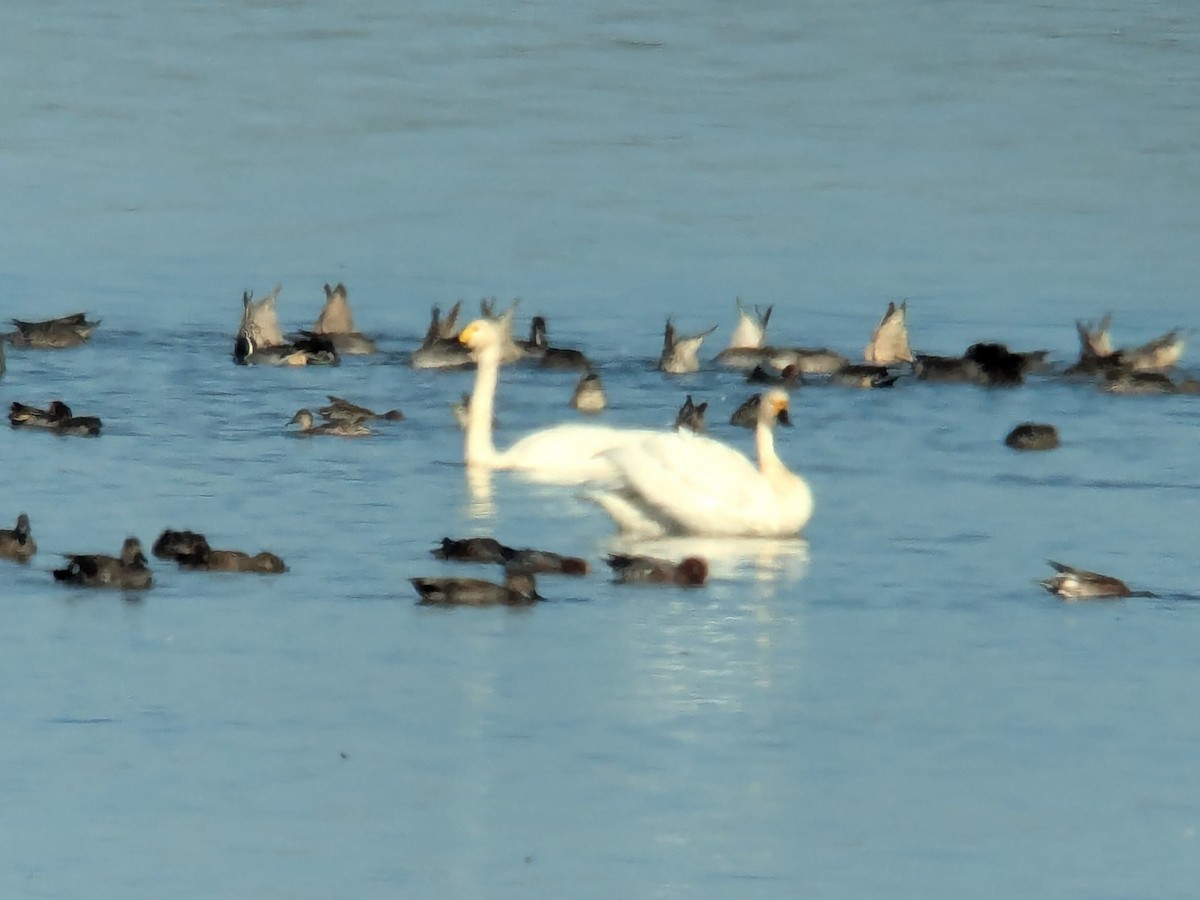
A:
[{"xmin": 590, "ymin": 388, "xmax": 812, "ymax": 538}]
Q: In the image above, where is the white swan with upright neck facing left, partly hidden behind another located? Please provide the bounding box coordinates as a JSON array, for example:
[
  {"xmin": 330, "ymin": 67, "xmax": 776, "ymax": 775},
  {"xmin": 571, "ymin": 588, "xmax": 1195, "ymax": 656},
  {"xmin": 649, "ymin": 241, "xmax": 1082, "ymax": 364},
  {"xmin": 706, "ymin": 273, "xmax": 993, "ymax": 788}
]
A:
[{"xmin": 458, "ymin": 319, "xmax": 658, "ymax": 485}]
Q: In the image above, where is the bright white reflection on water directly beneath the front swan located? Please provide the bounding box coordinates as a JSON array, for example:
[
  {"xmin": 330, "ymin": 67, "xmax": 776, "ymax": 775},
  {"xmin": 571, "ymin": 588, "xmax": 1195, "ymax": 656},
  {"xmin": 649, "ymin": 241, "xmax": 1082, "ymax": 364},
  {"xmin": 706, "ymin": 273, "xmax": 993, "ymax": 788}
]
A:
[{"xmin": 608, "ymin": 535, "xmax": 809, "ymax": 581}]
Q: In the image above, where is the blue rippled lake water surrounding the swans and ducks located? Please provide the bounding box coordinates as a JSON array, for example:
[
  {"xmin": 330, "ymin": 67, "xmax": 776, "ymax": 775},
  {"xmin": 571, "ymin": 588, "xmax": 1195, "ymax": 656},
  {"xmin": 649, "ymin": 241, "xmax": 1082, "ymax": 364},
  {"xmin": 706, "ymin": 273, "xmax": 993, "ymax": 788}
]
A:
[{"xmin": 0, "ymin": 0, "xmax": 1200, "ymax": 900}]
